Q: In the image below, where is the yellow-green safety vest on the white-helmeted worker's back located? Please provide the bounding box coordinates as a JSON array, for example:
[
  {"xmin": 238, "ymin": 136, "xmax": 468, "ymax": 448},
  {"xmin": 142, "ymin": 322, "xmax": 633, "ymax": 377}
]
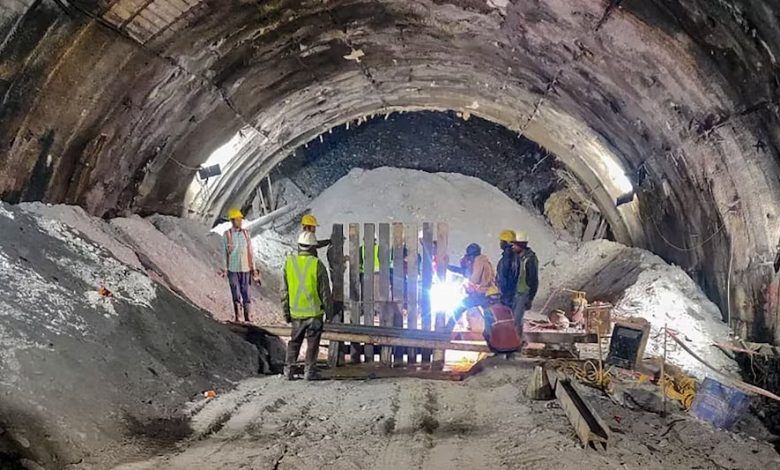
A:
[{"xmin": 284, "ymin": 255, "xmax": 323, "ymax": 318}]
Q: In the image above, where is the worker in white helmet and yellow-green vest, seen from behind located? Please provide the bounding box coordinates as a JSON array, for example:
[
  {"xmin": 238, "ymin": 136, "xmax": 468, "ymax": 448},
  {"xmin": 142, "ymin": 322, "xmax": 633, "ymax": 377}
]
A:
[{"xmin": 282, "ymin": 231, "xmax": 333, "ymax": 380}]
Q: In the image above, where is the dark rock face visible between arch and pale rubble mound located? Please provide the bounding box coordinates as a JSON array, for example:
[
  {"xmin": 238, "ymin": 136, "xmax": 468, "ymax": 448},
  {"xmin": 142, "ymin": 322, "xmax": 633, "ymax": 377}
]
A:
[{"xmin": 273, "ymin": 112, "xmax": 561, "ymax": 212}]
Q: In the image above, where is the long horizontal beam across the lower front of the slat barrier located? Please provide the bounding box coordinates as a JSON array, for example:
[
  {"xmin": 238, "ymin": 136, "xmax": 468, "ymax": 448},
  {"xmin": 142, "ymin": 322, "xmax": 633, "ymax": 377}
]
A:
[{"xmin": 253, "ymin": 325, "xmax": 490, "ymax": 353}]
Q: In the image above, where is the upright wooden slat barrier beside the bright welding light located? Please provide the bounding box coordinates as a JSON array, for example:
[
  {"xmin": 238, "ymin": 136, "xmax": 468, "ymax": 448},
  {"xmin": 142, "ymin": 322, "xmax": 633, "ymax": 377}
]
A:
[{"xmin": 328, "ymin": 222, "xmax": 449, "ymax": 366}]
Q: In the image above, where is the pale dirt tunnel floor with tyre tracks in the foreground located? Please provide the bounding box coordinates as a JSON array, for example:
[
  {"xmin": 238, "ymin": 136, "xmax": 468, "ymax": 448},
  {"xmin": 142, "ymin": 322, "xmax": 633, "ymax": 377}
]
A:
[{"xmin": 112, "ymin": 360, "xmax": 780, "ymax": 470}]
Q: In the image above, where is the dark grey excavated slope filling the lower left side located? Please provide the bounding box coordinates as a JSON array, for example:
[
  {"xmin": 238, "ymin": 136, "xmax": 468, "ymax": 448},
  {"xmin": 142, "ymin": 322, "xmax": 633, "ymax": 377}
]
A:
[{"xmin": 0, "ymin": 203, "xmax": 259, "ymax": 468}]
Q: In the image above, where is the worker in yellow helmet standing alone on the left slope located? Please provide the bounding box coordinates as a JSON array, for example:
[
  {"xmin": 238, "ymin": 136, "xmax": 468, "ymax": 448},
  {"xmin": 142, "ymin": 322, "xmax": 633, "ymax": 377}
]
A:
[{"xmin": 222, "ymin": 208, "xmax": 260, "ymax": 323}]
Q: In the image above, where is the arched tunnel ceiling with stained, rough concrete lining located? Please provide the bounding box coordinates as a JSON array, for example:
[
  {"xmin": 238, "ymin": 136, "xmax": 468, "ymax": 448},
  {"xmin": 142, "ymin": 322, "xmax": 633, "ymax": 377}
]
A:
[{"xmin": 0, "ymin": 0, "xmax": 780, "ymax": 342}]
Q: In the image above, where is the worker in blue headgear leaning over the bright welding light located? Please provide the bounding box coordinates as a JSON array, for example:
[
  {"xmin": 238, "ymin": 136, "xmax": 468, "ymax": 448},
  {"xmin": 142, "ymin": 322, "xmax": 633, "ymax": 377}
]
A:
[{"xmin": 447, "ymin": 243, "xmax": 498, "ymax": 331}]
